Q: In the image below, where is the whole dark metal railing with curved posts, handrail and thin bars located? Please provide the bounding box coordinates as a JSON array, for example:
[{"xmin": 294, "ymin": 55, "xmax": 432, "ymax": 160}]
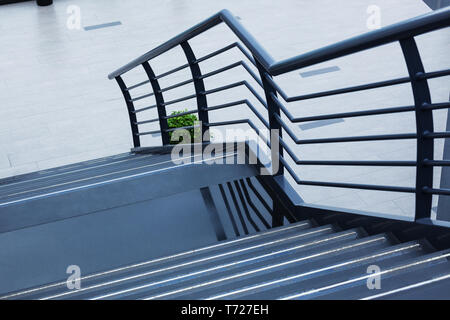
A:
[{"xmin": 108, "ymin": 8, "xmax": 450, "ymax": 220}]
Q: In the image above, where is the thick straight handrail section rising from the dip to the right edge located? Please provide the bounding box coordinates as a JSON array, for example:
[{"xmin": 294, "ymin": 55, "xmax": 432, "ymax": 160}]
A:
[{"xmin": 269, "ymin": 7, "xmax": 450, "ymax": 76}]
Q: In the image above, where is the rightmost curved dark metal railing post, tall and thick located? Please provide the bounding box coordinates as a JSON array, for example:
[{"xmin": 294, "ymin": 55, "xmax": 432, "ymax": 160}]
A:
[{"xmin": 400, "ymin": 37, "xmax": 434, "ymax": 220}]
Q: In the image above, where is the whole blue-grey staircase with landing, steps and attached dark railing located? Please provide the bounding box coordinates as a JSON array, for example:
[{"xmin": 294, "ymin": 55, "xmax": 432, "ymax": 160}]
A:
[{"xmin": 0, "ymin": 8, "xmax": 450, "ymax": 300}]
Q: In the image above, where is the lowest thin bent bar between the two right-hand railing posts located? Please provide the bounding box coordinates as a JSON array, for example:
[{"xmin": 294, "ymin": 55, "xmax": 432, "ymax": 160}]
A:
[{"xmin": 280, "ymin": 157, "xmax": 416, "ymax": 193}]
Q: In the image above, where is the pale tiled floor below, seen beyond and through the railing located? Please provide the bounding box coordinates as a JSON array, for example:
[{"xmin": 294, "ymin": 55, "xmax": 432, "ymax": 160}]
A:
[{"xmin": 0, "ymin": 0, "xmax": 450, "ymax": 215}]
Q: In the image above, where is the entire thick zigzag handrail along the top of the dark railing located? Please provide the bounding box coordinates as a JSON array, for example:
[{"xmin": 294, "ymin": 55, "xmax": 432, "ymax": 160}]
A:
[{"xmin": 108, "ymin": 7, "xmax": 450, "ymax": 79}]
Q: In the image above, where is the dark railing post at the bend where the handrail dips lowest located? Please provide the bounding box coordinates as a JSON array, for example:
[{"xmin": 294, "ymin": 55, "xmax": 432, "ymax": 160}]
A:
[{"xmin": 255, "ymin": 58, "xmax": 284, "ymax": 175}]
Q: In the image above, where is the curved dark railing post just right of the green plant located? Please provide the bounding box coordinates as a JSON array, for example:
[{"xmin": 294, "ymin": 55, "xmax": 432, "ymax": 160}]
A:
[{"xmin": 180, "ymin": 41, "xmax": 210, "ymax": 142}]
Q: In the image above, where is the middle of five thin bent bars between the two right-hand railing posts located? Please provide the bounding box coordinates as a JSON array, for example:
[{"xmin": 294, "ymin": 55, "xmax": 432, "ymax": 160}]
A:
[{"xmin": 274, "ymin": 114, "xmax": 417, "ymax": 144}]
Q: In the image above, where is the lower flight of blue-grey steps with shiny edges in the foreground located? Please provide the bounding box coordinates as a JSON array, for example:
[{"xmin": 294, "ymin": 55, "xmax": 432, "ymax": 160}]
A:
[{"xmin": 2, "ymin": 220, "xmax": 450, "ymax": 300}]
